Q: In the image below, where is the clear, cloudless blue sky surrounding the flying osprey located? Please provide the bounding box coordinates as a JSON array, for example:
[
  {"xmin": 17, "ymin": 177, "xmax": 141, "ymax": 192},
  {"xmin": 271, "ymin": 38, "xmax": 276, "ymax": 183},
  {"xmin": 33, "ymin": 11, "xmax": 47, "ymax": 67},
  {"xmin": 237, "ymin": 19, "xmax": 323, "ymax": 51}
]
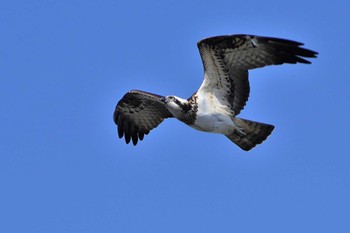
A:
[{"xmin": 0, "ymin": 0, "xmax": 350, "ymax": 233}]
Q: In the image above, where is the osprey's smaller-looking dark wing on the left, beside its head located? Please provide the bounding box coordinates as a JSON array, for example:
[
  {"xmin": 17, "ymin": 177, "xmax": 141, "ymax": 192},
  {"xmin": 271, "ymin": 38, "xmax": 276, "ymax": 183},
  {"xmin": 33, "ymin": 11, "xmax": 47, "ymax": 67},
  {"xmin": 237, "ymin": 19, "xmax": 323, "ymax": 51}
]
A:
[{"xmin": 113, "ymin": 90, "xmax": 173, "ymax": 145}]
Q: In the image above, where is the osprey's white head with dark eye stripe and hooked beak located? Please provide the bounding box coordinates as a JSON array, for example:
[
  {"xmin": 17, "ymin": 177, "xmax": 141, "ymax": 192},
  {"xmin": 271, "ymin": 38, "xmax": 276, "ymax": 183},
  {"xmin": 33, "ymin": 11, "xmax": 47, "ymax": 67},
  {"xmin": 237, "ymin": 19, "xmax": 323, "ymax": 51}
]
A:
[{"xmin": 160, "ymin": 95, "xmax": 191, "ymax": 117}]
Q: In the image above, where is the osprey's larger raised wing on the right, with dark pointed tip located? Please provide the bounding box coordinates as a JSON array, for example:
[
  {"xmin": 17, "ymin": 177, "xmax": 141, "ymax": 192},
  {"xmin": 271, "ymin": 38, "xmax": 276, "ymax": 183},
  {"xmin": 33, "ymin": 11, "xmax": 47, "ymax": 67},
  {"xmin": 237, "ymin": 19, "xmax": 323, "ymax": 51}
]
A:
[{"xmin": 197, "ymin": 35, "xmax": 317, "ymax": 115}]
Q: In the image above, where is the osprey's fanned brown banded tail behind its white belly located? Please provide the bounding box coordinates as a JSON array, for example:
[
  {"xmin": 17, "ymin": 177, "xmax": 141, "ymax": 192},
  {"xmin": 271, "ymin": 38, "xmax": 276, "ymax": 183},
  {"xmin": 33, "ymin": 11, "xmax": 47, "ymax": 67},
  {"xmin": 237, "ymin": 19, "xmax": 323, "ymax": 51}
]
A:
[{"xmin": 226, "ymin": 118, "xmax": 275, "ymax": 151}]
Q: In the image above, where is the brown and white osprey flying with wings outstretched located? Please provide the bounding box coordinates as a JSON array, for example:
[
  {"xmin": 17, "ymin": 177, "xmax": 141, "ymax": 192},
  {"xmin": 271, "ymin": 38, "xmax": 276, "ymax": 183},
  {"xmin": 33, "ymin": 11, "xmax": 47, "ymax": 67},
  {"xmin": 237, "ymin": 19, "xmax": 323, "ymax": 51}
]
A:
[{"xmin": 113, "ymin": 35, "xmax": 317, "ymax": 151}]
